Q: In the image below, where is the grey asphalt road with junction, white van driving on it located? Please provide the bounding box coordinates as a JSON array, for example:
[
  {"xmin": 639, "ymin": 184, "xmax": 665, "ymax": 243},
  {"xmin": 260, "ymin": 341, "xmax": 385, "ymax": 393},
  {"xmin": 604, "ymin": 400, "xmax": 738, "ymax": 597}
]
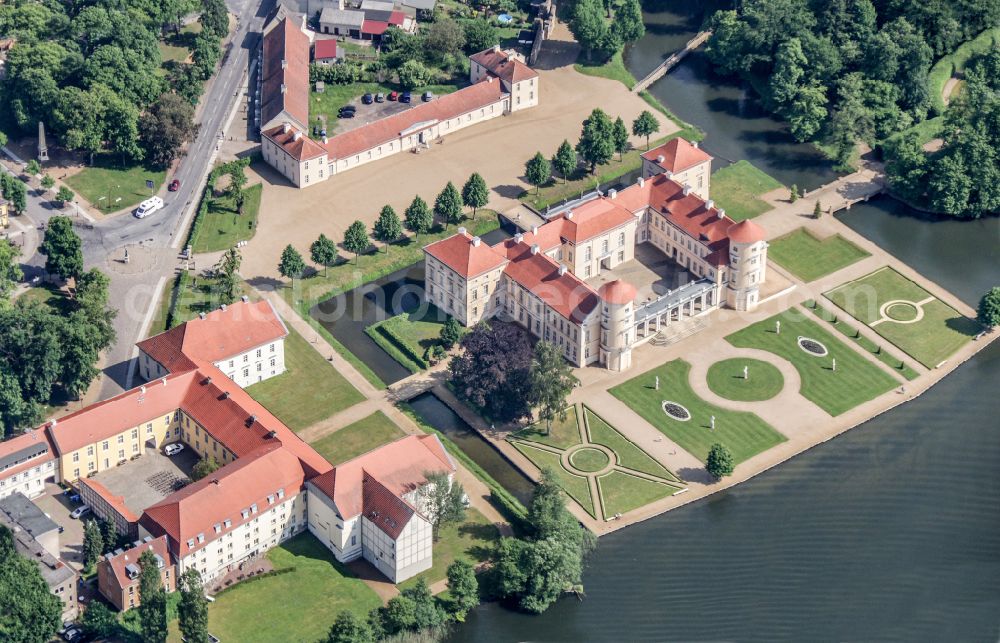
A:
[{"xmin": 7, "ymin": 0, "xmax": 274, "ymax": 399}]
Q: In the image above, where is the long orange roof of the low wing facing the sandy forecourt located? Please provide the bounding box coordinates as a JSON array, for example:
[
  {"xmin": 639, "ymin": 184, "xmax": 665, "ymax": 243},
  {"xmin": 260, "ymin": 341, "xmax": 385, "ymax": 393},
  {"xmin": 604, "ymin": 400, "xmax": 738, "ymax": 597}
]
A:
[{"xmin": 323, "ymin": 80, "xmax": 505, "ymax": 160}]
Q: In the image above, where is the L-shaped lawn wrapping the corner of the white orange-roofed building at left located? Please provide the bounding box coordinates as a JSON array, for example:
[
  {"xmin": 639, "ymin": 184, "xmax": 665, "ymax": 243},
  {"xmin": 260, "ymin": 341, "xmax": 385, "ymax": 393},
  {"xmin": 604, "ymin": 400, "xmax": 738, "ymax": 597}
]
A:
[{"xmin": 247, "ymin": 327, "xmax": 364, "ymax": 431}]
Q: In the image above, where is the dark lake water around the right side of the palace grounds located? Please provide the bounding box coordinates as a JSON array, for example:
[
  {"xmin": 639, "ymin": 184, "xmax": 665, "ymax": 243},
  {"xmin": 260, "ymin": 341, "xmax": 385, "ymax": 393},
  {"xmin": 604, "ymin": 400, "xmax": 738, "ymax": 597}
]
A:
[{"xmin": 451, "ymin": 1, "xmax": 1000, "ymax": 642}]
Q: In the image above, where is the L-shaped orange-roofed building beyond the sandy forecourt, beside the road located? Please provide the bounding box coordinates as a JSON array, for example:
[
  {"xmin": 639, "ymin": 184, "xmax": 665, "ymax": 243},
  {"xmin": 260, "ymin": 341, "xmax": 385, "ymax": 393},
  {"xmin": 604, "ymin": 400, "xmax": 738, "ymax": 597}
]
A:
[{"xmin": 258, "ymin": 12, "xmax": 539, "ymax": 188}]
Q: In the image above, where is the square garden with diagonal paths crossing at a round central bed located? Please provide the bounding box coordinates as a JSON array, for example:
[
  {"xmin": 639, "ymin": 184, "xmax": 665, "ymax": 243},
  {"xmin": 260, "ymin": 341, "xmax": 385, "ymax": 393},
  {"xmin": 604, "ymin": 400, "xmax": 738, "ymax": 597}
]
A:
[{"xmin": 510, "ymin": 405, "xmax": 684, "ymax": 520}]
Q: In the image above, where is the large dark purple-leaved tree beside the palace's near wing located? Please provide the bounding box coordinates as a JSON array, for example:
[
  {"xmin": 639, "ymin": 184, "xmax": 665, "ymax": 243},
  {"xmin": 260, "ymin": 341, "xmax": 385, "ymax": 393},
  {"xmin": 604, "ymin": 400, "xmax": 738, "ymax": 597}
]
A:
[{"xmin": 449, "ymin": 322, "xmax": 532, "ymax": 422}]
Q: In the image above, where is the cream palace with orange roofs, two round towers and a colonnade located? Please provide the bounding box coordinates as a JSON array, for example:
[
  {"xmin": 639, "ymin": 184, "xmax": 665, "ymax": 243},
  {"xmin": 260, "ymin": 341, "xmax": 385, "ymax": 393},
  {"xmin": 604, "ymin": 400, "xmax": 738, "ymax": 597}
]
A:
[{"xmin": 424, "ymin": 138, "xmax": 767, "ymax": 370}]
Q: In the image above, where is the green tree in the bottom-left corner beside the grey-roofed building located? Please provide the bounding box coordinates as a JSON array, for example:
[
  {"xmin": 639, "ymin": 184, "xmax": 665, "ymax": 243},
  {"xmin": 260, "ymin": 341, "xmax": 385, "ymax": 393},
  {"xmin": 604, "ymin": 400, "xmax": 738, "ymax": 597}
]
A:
[{"xmin": 0, "ymin": 525, "xmax": 62, "ymax": 643}]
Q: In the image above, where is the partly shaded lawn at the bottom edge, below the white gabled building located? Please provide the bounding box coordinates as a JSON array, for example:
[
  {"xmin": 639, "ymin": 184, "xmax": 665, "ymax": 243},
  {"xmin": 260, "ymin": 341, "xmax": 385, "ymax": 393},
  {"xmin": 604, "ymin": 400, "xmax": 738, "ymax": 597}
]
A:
[{"xmin": 208, "ymin": 533, "xmax": 382, "ymax": 641}]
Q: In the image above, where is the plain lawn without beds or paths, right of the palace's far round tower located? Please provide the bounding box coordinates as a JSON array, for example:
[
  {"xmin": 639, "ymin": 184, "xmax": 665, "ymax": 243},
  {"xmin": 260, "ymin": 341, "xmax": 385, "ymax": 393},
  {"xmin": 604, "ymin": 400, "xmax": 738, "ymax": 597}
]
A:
[{"xmin": 767, "ymin": 228, "xmax": 871, "ymax": 282}]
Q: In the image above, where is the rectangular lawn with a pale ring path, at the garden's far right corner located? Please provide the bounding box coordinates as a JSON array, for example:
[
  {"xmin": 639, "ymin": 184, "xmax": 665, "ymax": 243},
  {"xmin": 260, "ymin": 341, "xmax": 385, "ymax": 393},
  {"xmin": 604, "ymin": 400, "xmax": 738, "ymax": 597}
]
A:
[{"xmin": 825, "ymin": 267, "xmax": 982, "ymax": 368}]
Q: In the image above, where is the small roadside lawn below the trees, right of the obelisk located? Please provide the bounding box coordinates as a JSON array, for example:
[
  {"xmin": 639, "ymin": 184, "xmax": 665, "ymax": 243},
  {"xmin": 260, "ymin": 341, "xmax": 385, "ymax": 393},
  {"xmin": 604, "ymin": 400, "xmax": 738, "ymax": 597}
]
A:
[{"xmin": 65, "ymin": 154, "xmax": 167, "ymax": 216}]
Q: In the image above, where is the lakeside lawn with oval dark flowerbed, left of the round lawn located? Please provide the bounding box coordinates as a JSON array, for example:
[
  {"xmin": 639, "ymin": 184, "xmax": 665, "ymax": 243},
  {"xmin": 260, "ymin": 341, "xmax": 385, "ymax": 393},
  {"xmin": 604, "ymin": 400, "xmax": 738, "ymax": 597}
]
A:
[{"xmin": 610, "ymin": 360, "xmax": 785, "ymax": 463}]
